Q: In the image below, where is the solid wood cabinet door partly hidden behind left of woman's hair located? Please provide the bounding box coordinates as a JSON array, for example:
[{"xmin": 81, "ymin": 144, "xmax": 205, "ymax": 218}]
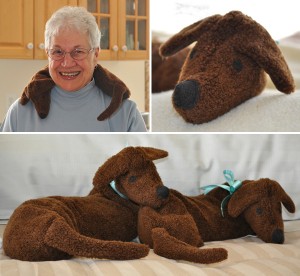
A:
[{"xmin": 34, "ymin": 0, "xmax": 78, "ymax": 59}]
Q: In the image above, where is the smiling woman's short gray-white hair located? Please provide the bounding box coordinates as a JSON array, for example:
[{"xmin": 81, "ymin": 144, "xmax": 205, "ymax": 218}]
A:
[{"xmin": 45, "ymin": 6, "xmax": 101, "ymax": 49}]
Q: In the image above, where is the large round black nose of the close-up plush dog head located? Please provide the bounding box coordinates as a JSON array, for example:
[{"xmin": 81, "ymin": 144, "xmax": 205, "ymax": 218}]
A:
[{"xmin": 172, "ymin": 80, "xmax": 200, "ymax": 109}]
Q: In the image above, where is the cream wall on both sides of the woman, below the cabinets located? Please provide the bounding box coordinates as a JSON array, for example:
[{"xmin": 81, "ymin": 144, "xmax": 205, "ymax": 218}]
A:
[{"xmin": 0, "ymin": 59, "xmax": 145, "ymax": 122}]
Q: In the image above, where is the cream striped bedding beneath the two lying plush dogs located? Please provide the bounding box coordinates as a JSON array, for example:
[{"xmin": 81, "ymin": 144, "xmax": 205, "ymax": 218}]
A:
[{"xmin": 0, "ymin": 220, "xmax": 300, "ymax": 276}]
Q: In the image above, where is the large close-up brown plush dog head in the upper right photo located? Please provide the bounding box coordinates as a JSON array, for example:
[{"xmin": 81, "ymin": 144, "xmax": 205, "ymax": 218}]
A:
[{"xmin": 160, "ymin": 11, "xmax": 295, "ymax": 124}]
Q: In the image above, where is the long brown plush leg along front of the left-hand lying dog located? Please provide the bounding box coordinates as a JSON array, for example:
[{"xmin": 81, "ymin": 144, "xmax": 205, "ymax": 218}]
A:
[{"xmin": 45, "ymin": 219, "xmax": 149, "ymax": 260}]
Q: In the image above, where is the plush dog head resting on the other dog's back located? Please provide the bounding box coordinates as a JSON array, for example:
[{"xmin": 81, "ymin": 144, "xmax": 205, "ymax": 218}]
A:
[{"xmin": 91, "ymin": 147, "xmax": 169, "ymax": 208}]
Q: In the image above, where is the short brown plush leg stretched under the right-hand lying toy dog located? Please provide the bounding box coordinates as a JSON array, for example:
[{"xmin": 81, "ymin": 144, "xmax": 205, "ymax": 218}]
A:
[{"xmin": 152, "ymin": 228, "xmax": 228, "ymax": 264}]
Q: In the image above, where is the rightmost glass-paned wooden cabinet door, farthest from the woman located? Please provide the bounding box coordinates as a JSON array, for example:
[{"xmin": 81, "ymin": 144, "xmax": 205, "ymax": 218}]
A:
[{"xmin": 118, "ymin": 0, "xmax": 149, "ymax": 59}]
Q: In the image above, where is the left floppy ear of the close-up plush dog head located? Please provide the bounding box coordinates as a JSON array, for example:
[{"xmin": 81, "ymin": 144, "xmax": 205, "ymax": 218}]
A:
[{"xmin": 159, "ymin": 15, "xmax": 221, "ymax": 57}]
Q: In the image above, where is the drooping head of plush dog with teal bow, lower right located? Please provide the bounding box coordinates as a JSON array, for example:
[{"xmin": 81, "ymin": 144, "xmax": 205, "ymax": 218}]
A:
[{"xmin": 228, "ymin": 178, "xmax": 295, "ymax": 243}]
